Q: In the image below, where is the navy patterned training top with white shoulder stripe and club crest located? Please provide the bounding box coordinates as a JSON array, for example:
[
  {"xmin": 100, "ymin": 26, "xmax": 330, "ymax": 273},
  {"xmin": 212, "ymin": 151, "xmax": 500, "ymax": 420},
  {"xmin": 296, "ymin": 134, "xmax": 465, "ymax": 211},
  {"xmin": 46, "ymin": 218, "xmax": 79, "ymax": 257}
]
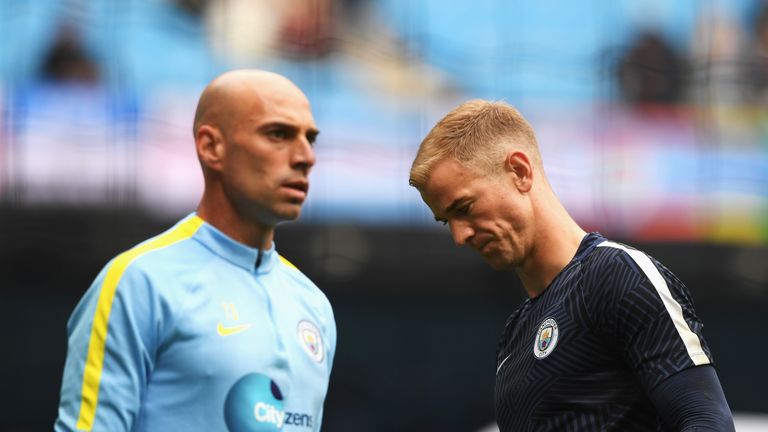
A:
[{"xmin": 495, "ymin": 233, "xmax": 716, "ymax": 432}]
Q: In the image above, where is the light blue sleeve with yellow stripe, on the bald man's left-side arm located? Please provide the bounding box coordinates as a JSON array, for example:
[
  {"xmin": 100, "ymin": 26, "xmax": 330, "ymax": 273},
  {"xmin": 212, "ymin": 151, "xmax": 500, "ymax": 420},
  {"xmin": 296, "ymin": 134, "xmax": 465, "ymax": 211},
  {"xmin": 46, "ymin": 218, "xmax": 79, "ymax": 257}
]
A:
[{"xmin": 55, "ymin": 257, "xmax": 160, "ymax": 431}]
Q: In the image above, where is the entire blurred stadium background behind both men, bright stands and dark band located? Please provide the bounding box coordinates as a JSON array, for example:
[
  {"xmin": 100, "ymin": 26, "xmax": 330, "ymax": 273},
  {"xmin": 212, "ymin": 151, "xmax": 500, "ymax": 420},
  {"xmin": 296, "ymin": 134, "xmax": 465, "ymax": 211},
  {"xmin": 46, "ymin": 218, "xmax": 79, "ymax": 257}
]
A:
[{"xmin": 0, "ymin": 0, "xmax": 768, "ymax": 432}]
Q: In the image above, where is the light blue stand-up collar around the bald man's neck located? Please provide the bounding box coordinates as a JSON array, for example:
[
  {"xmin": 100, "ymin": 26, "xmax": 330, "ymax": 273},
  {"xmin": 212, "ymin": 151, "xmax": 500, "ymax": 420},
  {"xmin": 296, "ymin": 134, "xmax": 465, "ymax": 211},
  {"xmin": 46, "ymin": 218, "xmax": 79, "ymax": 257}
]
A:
[{"xmin": 185, "ymin": 213, "xmax": 279, "ymax": 274}]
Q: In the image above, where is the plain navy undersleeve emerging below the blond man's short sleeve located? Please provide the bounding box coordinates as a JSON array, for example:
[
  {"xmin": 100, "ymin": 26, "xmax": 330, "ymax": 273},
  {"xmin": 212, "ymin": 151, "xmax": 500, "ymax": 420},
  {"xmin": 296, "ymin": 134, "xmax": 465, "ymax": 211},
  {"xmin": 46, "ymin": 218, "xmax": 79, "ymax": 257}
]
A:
[{"xmin": 649, "ymin": 365, "xmax": 735, "ymax": 432}]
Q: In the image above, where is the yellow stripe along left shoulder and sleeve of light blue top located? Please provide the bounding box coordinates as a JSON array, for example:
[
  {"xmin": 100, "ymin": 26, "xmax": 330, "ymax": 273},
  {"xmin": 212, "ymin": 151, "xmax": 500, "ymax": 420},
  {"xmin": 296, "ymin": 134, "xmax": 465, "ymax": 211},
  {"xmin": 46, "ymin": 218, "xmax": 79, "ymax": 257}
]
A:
[{"xmin": 77, "ymin": 216, "xmax": 203, "ymax": 430}]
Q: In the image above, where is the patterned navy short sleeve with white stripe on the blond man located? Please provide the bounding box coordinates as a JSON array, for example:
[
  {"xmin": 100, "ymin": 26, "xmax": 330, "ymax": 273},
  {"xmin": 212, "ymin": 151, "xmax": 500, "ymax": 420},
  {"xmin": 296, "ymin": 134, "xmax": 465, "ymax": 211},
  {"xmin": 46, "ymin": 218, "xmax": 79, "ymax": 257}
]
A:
[{"xmin": 594, "ymin": 242, "xmax": 712, "ymax": 392}]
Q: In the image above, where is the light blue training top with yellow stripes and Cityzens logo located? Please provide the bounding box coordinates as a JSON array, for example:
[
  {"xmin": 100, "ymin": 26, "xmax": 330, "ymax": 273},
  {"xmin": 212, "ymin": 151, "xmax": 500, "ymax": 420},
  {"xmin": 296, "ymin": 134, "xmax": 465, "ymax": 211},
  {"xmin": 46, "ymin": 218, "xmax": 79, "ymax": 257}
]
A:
[{"xmin": 55, "ymin": 213, "xmax": 336, "ymax": 432}]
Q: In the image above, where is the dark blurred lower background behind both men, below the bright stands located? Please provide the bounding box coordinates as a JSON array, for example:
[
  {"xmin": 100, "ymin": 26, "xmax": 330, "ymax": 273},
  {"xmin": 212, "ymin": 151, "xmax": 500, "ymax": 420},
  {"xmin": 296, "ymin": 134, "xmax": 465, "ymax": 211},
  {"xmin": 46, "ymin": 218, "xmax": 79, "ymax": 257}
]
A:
[{"xmin": 0, "ymin": 207, "xmax": 768, "ymax": 432}]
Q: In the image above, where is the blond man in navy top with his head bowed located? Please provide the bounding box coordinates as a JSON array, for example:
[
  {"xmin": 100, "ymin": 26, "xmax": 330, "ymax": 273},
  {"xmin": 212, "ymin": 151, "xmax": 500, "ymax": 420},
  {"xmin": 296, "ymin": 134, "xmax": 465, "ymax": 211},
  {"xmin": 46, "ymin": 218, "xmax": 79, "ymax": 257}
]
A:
[{"xmin": 410, "ymin": 100, "xmax": 733, "ymax": 431}]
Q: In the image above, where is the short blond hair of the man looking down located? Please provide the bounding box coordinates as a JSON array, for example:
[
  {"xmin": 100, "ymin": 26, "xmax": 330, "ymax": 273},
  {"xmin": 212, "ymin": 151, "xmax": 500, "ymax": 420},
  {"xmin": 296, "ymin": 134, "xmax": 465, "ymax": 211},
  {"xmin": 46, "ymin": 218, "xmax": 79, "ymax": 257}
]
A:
[{"xmin": 409, "ymin": 99, "xmax": 542, "ymax": 189}]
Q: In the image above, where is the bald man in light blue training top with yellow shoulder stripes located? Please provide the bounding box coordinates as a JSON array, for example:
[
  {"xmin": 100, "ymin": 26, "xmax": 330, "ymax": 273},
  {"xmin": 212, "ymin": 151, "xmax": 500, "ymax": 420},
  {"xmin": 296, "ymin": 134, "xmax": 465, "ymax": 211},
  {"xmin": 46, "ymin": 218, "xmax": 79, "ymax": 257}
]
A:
[{"xmin": 55, "ymin": 70, "xmax": 336, "ymax": 431}]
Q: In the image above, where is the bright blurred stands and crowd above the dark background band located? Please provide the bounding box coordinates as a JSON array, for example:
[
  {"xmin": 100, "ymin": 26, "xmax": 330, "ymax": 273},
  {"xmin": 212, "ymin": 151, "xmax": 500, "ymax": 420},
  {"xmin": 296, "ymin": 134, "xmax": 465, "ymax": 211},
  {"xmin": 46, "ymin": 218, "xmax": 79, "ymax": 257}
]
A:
[{"xmin": 0, "ymin": 0, "xmax": 768, "ymax": 241}]
